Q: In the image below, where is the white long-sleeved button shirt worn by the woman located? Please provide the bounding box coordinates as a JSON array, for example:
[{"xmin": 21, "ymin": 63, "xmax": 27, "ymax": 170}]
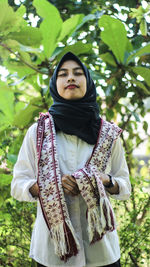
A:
[{"xmin": 11, "ymin": 123, "xmax": 131, "ymax": 267}]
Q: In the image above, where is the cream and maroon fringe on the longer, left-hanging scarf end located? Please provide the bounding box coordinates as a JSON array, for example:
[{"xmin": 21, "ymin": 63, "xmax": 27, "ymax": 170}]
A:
[{"xmin": 51, "ymin": 221, "xmax": 80, "ymax": 261}]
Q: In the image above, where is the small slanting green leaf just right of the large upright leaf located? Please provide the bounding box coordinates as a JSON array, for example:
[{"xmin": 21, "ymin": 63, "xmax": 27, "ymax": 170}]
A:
[{"xmin": 58, "ymin": 14, "xmax": 84, "ymax": 41}]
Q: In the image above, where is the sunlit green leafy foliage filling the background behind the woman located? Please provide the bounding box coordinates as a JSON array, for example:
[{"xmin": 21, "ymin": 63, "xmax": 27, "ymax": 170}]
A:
[{"xmin": 0, "ymin": 0, "xmax": 150, "ymax": 267}]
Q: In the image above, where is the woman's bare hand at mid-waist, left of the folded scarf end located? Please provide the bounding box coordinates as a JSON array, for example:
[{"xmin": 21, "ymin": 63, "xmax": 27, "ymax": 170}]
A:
[{"xmin": 62, "ymin": 174, "xmax": 80, "ymax": 196}]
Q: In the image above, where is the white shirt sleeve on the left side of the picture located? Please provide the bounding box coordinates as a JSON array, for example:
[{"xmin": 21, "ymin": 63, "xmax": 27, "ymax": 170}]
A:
[{"xmin": 11, "ymin": 124, "xmax": 37, "ymax": 202}]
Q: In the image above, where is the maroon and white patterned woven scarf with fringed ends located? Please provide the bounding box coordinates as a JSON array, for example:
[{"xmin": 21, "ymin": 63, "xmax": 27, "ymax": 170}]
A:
[{"xmin": 37, "ymin": 113, "xmax": 121, "ymax": 261}]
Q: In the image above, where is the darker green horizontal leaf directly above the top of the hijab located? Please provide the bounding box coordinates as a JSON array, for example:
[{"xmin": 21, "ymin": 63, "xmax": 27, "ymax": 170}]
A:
[{"xmin": 57, "ymin": 41, "xmax": 92, "ymax": 61}]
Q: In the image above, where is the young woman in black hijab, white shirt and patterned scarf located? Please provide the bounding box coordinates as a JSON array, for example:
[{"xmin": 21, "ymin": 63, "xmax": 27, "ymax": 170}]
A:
[{"xmin": 11, "ymin": 52, "xmax": 131, "ymax": 267}]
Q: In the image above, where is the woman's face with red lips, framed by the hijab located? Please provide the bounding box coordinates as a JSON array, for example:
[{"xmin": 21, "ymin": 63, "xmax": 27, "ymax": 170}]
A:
[{"xmin": 56, "ymin": 60, "xmax": 86, "ymax": 100}]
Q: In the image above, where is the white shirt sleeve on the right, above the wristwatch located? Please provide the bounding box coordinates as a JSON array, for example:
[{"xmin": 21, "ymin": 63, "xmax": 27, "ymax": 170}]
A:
[{"xmin": 109, "ymin": 138, "xmax": 131, "ymax": 200}]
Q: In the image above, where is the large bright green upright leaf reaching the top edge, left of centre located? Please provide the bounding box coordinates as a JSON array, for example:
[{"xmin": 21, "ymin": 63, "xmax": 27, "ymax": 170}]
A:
[{"xmin": 33, "ymin": 0, "xmax": 63, "ymax": 58}]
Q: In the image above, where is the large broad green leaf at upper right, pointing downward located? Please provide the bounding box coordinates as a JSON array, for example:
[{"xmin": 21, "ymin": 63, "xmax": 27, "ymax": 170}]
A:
[{"xmin": 98, "ymin": 15, "xmax": 128, "ymax": 63}]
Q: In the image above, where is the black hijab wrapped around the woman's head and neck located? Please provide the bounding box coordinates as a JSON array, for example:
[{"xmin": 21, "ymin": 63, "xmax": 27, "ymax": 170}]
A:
[{"xmin": 49, "ymin": 52, "xmax": 101, "ymax": 144}]
